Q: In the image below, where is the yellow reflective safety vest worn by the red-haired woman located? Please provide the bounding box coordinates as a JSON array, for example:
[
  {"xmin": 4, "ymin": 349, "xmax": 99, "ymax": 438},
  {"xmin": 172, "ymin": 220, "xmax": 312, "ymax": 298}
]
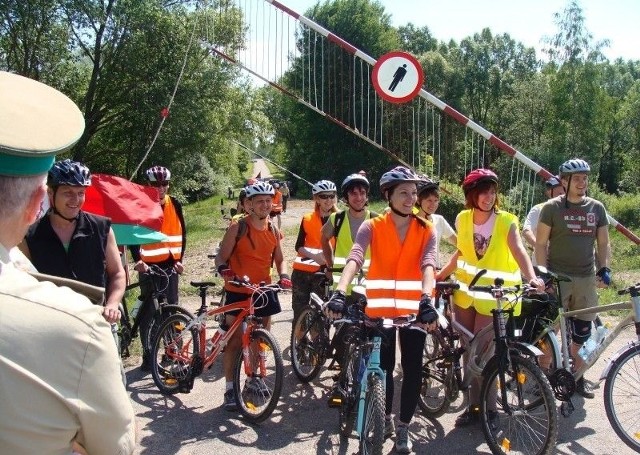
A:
[{"xmin": 453, "ymin": 210, "xmax": 522, "ymax": 316}]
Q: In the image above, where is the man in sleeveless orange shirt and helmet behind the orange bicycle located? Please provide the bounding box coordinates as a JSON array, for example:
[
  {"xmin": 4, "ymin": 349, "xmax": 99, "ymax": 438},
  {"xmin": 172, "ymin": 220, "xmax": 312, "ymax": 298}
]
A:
[{"xmin": 215, "ymin": 182, "xmax": 291, "ymax": 411}]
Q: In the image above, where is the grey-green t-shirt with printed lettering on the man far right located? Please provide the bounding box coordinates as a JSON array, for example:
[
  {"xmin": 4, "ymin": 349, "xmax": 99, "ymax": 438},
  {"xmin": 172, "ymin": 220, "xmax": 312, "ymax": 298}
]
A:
[{"xmin": 539, "ymin": 196, "xmax": 609, "ymax": 276}]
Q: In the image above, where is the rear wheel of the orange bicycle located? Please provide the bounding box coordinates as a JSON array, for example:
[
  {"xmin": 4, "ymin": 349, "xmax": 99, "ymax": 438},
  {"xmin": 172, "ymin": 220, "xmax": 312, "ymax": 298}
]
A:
[{"xmin": 151, "ymin": 313, "xmax": 200, "ymax": 395}]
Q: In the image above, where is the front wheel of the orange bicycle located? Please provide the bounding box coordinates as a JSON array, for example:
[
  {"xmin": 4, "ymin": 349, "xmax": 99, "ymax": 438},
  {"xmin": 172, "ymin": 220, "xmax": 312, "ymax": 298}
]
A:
[{"xmin": 233, "ymin": 329, "xmax": 284, "ymax": 423}]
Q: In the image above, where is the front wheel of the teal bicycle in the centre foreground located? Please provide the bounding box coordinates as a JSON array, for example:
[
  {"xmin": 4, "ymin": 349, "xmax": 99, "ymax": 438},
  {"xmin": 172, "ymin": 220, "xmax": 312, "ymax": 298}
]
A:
[{"xmin": 360, "ymin": 374, "xmax": 385, "ymax": 455}]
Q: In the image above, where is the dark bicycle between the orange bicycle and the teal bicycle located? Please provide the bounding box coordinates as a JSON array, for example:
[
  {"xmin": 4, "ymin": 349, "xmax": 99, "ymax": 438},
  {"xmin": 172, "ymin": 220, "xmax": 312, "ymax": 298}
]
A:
[{"xmin": 290, "ymin": 268, "xmax": 356, "ymax": 383}]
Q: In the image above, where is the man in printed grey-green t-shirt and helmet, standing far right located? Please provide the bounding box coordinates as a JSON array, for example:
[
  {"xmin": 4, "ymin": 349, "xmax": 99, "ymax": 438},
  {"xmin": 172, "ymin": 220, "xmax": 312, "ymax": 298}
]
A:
[{"xmin": 535, "ymin": 159, "xmax": 611, "ymax": 398}]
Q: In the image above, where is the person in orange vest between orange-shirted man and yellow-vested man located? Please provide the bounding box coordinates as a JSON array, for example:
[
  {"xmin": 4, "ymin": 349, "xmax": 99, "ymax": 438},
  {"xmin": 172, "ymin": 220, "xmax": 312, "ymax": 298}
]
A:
[{"xmin": 291, "ymin": 180, "xmax": 338, "ymax": 332}]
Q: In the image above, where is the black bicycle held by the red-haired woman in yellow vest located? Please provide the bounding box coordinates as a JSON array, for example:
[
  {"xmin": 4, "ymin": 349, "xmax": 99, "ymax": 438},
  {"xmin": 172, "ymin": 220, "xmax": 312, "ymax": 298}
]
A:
[{"xmin": 418, "ymin": 270, "xmax": 558, "ymax": 454}]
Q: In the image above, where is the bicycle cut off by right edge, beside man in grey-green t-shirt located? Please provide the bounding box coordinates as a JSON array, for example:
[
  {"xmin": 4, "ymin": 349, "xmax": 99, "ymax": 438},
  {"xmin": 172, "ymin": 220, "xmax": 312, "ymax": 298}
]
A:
[{"xmin": 532, "ymin": 267, "xmax": 640, "ymax": 452}]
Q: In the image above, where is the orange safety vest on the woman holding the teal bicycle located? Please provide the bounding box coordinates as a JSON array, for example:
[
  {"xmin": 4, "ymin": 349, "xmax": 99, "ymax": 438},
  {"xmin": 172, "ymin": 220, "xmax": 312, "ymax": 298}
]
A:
[{"xmin": 365, "ymin": 213, "xmax": 433, "ymax": 318}]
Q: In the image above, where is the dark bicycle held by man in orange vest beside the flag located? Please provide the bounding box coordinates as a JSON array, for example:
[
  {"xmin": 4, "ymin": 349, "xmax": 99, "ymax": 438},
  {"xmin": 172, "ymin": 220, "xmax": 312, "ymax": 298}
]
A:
[{"xmin": 116, "ymin": 264, "xmax": 193, "ymax": 358}]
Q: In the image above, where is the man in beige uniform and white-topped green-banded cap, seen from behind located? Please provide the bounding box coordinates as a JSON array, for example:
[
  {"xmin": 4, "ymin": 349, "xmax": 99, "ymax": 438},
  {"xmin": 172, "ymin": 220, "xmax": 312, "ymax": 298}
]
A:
[{"xmin": 0, "ymin": 72, "xmax": 135, "ymax": 455}]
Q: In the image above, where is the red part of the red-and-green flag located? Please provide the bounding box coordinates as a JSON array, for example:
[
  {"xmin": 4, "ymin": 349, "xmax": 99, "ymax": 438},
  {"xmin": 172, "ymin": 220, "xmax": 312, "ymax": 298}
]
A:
[{"xmin": 82, "ymin": 174, "xmax": 163, "ymax": 231}]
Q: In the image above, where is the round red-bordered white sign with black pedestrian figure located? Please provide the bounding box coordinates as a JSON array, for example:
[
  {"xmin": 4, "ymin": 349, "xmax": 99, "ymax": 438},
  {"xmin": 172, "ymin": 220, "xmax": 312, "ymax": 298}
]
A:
[{"xmin": 371, "ymin": 52, "xmax": 424, "ymax": 103}]
